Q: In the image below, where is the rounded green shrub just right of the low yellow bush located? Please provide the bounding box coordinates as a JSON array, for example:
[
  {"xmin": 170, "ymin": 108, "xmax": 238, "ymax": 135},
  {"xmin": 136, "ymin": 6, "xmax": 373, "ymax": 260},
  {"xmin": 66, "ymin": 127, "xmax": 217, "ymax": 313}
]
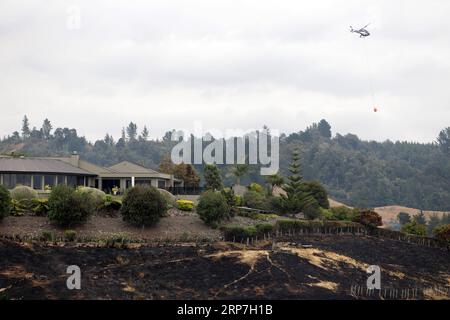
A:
[{"xmin": 197, "ymin": 190, "xmax": 230, "ymax": 226}]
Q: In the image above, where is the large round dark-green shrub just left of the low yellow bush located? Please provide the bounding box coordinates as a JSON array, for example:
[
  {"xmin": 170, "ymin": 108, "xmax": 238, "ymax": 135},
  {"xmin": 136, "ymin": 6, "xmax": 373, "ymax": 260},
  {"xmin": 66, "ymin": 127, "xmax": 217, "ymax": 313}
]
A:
[{"xmin": 120, "ymin": 186, "xmax": 167, "ymax": 227}]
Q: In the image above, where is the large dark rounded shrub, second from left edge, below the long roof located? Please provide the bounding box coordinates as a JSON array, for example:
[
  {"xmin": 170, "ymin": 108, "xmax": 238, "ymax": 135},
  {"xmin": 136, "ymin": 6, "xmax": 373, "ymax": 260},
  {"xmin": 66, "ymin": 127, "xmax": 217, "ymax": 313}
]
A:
[{"xmin": 48, "ymin": 185, "xmax": 95, "ymax": 227}]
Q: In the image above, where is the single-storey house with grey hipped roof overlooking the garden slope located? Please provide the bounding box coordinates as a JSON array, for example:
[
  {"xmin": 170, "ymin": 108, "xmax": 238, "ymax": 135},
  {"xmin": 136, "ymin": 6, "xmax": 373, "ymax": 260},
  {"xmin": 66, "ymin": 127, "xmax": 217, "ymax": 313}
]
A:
[{"xmin": 0, "ymin": 154, "xmax": 183, "ymax": 192}]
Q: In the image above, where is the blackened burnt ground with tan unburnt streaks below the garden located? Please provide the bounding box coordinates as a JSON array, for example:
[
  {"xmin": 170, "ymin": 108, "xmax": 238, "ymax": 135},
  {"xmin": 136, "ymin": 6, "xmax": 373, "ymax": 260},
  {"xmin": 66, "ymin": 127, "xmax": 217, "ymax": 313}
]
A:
[{"xmin": 0, "ymin": 236, "xmax": 450, "ymax": 299}]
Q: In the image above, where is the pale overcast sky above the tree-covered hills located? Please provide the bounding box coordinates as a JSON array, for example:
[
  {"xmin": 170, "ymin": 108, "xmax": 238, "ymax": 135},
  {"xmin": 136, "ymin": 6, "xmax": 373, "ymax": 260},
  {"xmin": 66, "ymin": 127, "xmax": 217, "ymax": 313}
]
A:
[{"xmin": 0, "ymin": 0, "xmax": 450, "ymax": 142}]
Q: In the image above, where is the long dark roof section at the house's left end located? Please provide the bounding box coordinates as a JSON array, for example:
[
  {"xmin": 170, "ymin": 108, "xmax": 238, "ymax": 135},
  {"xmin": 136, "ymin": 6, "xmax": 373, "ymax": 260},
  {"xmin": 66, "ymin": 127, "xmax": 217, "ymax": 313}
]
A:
[{"xmin": 0, "ymin": 157, "xmax": 96, "ymax": 176}]
